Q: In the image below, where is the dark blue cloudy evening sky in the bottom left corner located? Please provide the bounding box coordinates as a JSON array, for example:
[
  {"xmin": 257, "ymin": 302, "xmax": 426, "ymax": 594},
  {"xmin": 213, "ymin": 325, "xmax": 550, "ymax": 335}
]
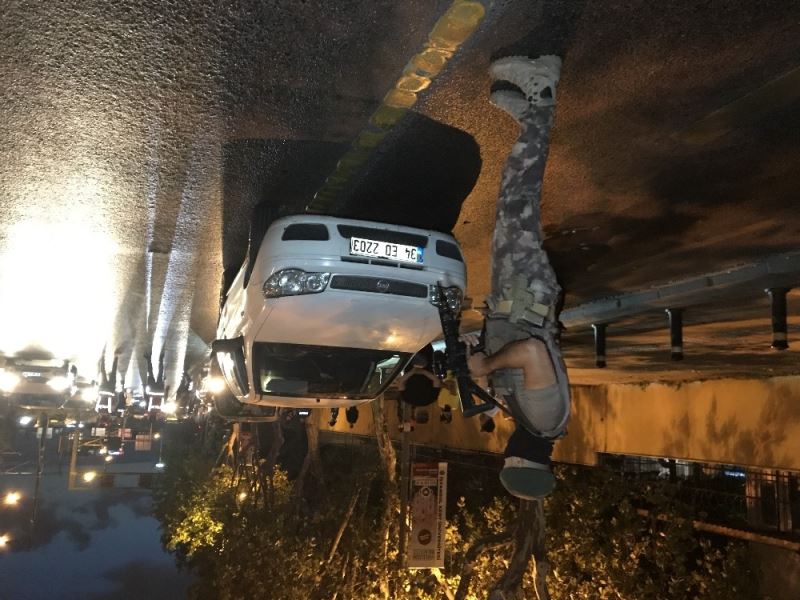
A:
[{"xmin": 0, "ymin": 428, "xmax": 192, "ymax": 600}]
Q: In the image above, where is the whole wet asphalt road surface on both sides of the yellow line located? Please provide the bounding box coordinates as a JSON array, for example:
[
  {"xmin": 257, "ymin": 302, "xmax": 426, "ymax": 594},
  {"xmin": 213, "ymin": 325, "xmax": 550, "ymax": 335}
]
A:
[{"xmin": 0, "ymin": 0, "xmax": 800, "ymax": 389}]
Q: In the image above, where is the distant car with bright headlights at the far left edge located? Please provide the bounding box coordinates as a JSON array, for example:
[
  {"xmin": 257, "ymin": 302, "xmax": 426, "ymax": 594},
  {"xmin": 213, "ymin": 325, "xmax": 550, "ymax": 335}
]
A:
[{"xmin": 0, "ymin": 356, "xmax": 77, "ymax": 408}]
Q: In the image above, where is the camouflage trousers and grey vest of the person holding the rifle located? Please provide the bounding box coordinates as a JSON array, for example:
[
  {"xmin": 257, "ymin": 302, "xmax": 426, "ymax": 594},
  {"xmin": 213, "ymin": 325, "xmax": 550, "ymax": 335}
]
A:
[{"xmin": 486, "ymin": 107, "xmax": 570, "ymax": 441}]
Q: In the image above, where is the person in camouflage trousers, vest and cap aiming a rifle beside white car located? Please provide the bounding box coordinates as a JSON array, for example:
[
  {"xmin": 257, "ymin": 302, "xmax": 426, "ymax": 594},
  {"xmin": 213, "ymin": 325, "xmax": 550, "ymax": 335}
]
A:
[{"xmin": 469, "ymin": 56, "xmax": 570, "ymax": 499}]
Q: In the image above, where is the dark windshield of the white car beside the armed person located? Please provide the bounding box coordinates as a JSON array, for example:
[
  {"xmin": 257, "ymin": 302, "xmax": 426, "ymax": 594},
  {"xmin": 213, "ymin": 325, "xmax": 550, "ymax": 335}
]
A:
[{"xmin": 253, "ymin": 342, "xmax": 411, "ymax": 400}]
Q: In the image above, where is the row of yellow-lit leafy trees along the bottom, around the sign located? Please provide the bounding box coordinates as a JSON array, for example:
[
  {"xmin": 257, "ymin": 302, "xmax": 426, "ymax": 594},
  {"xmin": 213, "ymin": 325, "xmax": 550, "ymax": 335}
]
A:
[{"xmin": 156, "ymin": 420, "xmax": 755, "ymax": 600}]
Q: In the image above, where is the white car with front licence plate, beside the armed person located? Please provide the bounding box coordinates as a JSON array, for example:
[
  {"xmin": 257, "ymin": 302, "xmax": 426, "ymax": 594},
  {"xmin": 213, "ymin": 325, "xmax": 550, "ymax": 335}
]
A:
[{"xmin": 211, "ymin": 215, "xmax": 466, "ymax": 408}]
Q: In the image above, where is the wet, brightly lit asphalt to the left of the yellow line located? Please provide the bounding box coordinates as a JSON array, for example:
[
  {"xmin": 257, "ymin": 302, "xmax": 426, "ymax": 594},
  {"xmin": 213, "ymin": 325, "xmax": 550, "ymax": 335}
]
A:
[{"xmin": 0, "ymin": 2, "xmax": 472, "ymax": 389}]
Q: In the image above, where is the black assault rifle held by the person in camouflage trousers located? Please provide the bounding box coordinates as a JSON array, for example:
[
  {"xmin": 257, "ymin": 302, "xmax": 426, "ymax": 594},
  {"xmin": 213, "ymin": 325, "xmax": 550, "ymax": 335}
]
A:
[{"xmin": 436, "ymin": 283, "xmax": 508, "ymax": 417}]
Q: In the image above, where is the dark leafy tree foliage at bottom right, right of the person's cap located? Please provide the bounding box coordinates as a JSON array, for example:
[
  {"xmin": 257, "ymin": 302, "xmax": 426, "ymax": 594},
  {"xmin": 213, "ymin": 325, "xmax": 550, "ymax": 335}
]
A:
[{"xmin": 547, "ymin": 467, "xmax": 756, "ymax": 600}]
